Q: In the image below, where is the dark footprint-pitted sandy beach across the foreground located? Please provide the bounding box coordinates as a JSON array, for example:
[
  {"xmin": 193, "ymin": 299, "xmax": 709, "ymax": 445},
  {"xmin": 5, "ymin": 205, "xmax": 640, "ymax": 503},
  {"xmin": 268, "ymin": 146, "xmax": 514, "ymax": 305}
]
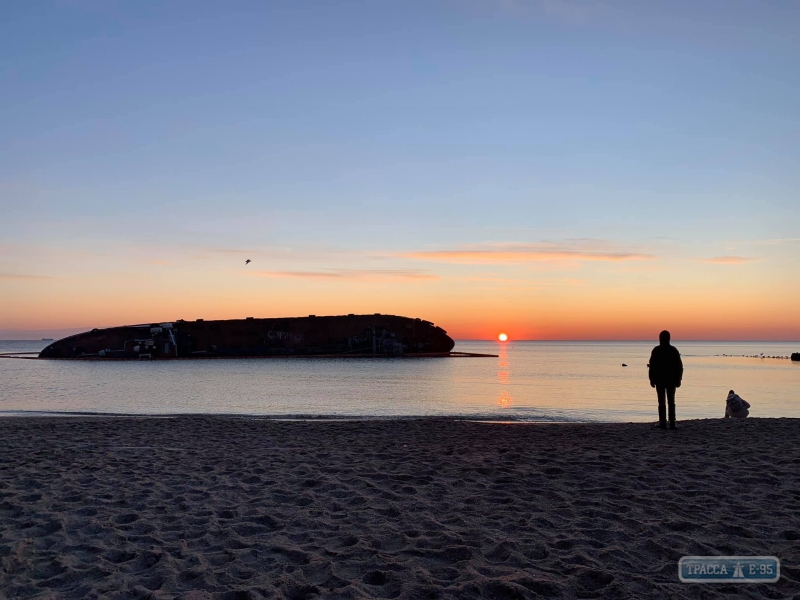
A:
[{"xmin": 0, "ymin": 417, "xmax": 800, "ymax": 599}]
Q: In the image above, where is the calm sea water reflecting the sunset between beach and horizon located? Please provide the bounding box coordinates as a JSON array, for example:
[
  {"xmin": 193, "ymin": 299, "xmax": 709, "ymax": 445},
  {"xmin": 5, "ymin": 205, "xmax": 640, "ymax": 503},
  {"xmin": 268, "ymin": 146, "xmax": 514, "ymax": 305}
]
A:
[{"xmin": 0, "ymin": 342, "xmax": 800, "ymax": 421}]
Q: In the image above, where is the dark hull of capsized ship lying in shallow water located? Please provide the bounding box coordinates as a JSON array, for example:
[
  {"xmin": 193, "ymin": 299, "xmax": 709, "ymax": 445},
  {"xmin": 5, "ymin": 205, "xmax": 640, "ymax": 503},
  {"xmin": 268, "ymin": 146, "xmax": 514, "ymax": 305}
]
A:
[{"xmin": 39, "ymin": 314, "xmax": 462, "ymax": 360}]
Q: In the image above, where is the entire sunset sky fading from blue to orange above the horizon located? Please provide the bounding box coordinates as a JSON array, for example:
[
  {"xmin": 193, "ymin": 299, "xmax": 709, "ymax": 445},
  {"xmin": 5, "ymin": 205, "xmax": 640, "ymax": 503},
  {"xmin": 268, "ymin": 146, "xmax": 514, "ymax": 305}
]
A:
[{"xmin": 0, "ymin": 0, "xmax": 800, "ymax": 341}]
